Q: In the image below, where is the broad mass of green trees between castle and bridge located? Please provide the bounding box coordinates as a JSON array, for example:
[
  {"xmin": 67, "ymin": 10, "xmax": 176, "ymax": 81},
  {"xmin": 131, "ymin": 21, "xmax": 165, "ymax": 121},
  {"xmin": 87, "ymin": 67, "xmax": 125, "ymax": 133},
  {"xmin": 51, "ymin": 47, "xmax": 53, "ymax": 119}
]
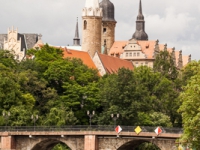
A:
[{"xmin": 0, "ymin": 45, "xmax": 200, "ymax": 149}]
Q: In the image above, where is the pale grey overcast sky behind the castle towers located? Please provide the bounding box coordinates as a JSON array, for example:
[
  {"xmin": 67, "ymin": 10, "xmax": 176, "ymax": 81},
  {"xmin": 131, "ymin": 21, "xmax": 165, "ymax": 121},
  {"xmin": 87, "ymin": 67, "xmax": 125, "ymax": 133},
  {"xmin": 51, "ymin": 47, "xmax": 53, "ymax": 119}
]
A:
[{"xmin": 0, "ymin": 0, "xmax": 200, "ymax": 60}]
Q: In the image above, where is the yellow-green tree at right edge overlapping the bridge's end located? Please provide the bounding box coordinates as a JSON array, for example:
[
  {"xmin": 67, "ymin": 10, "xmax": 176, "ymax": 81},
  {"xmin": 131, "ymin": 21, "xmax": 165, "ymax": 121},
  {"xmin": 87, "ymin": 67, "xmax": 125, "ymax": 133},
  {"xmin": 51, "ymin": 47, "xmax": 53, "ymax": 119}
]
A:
[{"xmin": 179, "ymin": 72, "xmax": 200, "ymax": 149}]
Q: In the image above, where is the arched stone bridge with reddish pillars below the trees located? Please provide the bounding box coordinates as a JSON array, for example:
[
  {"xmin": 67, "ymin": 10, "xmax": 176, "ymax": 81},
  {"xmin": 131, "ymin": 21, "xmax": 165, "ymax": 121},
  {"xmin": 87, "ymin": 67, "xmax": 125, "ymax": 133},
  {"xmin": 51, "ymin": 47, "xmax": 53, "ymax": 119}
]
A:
[{"xmin": 0, "ymin": 127, "xmax": 181, "ymax": 150}]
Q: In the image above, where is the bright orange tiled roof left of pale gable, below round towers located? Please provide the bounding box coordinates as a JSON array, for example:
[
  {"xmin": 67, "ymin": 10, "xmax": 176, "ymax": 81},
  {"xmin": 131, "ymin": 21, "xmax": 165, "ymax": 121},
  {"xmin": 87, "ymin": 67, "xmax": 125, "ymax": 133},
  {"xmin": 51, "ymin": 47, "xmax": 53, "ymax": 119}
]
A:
[{"xmin": 61, "ymin": 47, "xmax": 97, "ymax": 69}]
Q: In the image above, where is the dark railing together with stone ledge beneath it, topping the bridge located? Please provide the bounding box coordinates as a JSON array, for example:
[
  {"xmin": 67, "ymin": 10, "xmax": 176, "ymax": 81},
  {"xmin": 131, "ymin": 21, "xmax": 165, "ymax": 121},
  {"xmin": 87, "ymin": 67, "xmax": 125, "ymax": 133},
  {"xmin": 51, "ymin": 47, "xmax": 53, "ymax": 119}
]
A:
[{"xmin": 0, "ymin": 126, "xmax": 182, "ymax": 138}]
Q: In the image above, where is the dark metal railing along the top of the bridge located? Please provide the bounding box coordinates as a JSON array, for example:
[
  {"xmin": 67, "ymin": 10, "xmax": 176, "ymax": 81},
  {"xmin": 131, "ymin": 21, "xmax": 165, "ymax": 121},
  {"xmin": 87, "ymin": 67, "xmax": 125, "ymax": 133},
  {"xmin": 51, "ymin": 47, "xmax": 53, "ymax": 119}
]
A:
[{"xmin": 0, "ymin": 125, "xmax": 183, "ymax": 134}]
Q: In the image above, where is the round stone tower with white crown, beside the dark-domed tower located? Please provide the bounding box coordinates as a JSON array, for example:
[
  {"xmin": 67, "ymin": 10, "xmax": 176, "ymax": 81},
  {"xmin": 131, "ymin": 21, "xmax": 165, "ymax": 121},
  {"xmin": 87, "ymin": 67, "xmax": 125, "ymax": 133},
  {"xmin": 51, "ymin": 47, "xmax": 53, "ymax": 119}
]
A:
[{"xmin": 82, "ymin": 0, "xmax": 102, "ymax": 57}]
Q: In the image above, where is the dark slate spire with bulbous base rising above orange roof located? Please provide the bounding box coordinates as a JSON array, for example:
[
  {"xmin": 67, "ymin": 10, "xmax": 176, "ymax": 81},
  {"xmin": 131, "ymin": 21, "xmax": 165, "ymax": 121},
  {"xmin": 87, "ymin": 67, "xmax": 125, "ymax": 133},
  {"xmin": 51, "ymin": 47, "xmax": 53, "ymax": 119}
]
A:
[{"xmin": 132, "ymin": 0, "xmax": 148, "ymax": 41}]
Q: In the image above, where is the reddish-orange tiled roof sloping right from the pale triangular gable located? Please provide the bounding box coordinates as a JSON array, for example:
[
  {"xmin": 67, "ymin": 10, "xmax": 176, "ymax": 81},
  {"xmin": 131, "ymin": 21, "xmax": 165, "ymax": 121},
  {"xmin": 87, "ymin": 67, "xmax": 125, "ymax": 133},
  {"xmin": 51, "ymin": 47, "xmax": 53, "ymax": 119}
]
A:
[{"xmin": 98, "ymin": 53, "xmax": 134, "ymax": 74}]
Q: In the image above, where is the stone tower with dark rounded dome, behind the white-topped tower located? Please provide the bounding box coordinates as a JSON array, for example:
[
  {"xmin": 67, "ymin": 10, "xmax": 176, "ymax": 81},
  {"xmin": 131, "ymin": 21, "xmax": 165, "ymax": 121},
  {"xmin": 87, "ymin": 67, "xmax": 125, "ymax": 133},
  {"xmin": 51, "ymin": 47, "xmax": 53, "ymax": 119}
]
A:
[{"xmin": 100, "ymin": 0, "xmax": 117, "ymax": 53}]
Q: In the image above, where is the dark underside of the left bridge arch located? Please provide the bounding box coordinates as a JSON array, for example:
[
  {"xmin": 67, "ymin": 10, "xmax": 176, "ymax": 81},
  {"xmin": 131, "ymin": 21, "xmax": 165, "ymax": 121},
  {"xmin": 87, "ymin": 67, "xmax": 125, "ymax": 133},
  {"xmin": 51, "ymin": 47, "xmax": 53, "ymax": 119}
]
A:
[{"xmin": 31, "ymin": 138, "xmax": 75, "ymax": 150}]
